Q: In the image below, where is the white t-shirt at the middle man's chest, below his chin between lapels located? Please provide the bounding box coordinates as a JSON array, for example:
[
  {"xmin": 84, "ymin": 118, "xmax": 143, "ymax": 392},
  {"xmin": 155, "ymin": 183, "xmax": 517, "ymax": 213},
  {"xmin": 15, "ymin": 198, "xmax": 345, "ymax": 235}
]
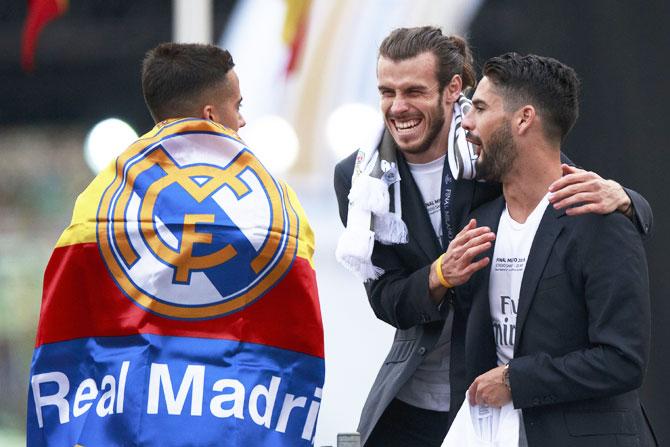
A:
[{"xmin": 407, "ymin": 155, "xmax": 446, "ymax": 244}]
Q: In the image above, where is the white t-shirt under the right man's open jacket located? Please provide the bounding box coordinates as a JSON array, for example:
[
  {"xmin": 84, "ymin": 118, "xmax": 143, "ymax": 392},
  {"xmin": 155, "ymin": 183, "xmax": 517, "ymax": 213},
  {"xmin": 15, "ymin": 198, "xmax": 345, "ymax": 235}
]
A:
[{"xmin": 489, "ymin": 194, "xmax": 549, "ymax": 365}]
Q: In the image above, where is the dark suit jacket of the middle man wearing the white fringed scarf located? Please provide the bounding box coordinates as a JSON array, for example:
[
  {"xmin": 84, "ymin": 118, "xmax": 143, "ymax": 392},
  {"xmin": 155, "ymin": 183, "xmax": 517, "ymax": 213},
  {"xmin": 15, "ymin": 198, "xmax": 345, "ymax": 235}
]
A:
[{"xmin": 334, "ymin": 132, "xmax": 652, "ymax": 445}]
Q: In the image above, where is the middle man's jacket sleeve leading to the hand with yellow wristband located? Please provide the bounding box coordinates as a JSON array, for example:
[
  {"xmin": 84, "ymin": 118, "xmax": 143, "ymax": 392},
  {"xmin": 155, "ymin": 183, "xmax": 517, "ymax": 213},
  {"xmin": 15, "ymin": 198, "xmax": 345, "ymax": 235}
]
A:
[{"xmin": 334, "ymin": 154, "xmax": 453, "ymax": 329}]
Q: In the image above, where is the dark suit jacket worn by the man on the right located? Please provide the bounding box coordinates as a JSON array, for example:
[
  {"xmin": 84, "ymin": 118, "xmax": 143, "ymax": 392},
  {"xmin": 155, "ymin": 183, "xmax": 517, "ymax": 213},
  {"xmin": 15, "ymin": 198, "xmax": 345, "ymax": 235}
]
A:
[{"xmin": 460, "ymin": 197, "xmax": 656, "ymax": 447}]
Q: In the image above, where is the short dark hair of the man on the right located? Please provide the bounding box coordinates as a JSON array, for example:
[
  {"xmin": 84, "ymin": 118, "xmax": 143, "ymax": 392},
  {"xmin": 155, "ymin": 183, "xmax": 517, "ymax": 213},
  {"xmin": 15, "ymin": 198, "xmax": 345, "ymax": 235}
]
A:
[{"xmin": 482, "ymin": 53, "xmax": 580, "ymax": 141}]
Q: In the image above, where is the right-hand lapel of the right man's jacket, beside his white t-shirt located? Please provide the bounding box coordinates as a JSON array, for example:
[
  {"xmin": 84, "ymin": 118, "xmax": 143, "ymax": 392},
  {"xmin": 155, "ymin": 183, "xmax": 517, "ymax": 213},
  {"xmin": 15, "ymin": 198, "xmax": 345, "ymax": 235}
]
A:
[{"xmin": 514, "ymin": 205, "xmax": 565, "ymax": 354}]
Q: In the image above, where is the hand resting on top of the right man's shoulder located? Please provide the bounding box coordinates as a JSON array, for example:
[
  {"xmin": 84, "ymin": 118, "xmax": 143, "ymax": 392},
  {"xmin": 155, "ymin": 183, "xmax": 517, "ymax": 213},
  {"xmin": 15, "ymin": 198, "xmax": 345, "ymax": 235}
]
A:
[{"xmin": 549, "ymin": 164, "xmax": 633, "ymax": 218}]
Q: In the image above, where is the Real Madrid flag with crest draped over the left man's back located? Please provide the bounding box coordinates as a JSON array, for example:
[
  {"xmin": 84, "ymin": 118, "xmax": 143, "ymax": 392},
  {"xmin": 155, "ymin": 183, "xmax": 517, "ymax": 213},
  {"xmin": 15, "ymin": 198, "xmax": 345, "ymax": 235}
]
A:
[{"xmin": 27, "ymin": 119, "xmax": 324, "ymax": 447}]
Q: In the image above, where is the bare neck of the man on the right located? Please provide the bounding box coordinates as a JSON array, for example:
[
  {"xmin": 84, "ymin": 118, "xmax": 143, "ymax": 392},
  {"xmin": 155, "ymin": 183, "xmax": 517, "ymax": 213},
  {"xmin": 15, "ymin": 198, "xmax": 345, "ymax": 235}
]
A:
[{"xmin": 503, "ymin": 148, "xmax": 562, "ymax": 223}]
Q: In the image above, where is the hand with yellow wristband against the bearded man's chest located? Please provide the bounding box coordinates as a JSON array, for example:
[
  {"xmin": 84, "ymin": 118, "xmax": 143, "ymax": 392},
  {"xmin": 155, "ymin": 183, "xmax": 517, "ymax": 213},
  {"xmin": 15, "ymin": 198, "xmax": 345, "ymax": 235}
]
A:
[{"xmin": 428, "ymin": 219, "xmax": 495, "ymax": 301}]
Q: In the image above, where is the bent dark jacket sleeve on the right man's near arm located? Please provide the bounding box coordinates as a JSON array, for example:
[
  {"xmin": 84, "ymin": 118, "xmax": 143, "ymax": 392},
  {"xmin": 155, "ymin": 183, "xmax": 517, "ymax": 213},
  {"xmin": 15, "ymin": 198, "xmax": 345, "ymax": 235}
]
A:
[{"xmin": 509, "ymin": 213, "xmax": 650, "ymax": 408}]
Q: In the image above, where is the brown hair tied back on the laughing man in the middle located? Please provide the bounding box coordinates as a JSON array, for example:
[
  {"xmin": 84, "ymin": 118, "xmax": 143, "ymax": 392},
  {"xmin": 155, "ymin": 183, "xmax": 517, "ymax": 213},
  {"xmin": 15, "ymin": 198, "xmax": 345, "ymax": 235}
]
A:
[{"xmin": 379, "ymin": 26, "xmax": 477, "ymax": 91}]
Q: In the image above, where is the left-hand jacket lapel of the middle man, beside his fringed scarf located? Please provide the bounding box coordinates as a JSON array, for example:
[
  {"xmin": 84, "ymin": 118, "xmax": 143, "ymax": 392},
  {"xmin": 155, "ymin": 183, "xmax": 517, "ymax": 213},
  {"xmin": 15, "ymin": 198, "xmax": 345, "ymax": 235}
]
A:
[{"xmin": 398, "ymin": 155, "xmax": 441, "ymax": 261}]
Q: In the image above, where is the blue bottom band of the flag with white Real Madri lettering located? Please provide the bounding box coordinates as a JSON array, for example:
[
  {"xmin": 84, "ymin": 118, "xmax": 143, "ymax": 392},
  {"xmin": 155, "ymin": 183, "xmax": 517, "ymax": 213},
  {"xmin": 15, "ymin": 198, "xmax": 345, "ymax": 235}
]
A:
[{"xmin": 27, "ymin": 334, "xmax": 324, "ymax": 447}]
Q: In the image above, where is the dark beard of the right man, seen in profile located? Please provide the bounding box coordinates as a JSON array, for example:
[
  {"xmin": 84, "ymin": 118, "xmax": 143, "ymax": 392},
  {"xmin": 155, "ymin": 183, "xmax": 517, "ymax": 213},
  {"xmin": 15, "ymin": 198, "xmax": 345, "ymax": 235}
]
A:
[{"xmin": 476, "ymin": 123, "xmax": 518, "ymax": 183}]
